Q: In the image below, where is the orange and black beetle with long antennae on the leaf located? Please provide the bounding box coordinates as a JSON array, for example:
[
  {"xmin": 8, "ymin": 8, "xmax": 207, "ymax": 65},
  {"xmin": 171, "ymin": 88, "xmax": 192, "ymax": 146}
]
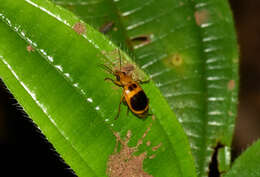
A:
[{"xmin": 102, "ymin": 50, "xmax": 150, "ymax": 119}]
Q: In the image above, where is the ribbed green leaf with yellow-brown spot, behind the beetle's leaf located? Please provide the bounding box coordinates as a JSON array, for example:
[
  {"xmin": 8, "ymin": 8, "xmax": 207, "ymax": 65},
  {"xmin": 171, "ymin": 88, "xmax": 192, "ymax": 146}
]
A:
[{"xmin": 54, "ymin": 0, "xmax": 238, "ymax": 176}]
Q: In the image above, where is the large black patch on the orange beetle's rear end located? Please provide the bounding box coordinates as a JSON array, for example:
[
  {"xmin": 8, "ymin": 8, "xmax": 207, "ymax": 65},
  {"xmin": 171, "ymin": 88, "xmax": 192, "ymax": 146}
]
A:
[{"xmin": 130, "ymin": 90, "xmax": 148, "ymax": 111}]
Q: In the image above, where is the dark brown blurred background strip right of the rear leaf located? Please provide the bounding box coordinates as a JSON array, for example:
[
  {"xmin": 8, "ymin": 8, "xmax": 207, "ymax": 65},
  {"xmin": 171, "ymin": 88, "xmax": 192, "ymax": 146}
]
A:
[{"xmin": 230, "ymin": 0, "xmax": 260, "ymax": 155}]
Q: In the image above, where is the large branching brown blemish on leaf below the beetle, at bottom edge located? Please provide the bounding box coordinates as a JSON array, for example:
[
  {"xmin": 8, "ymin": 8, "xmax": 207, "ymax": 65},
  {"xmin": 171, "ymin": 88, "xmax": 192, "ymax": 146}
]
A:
[{"xmin": 107, "ymin": 124, "xmax": 161, "ymax": 177}]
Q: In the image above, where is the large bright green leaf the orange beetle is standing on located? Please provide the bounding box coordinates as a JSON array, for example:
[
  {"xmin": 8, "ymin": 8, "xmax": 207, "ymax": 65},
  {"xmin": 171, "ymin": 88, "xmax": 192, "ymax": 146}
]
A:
[{"xmin": 0, "ymin": 0, "xmax": 195, "ymax": 177}]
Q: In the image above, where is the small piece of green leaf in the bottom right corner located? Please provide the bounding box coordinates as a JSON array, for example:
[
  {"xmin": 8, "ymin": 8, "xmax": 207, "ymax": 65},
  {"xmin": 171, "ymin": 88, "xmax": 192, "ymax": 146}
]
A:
[{"xmin": 224, "ymin": 140, "xmax": 260, "ymax": 177}]
